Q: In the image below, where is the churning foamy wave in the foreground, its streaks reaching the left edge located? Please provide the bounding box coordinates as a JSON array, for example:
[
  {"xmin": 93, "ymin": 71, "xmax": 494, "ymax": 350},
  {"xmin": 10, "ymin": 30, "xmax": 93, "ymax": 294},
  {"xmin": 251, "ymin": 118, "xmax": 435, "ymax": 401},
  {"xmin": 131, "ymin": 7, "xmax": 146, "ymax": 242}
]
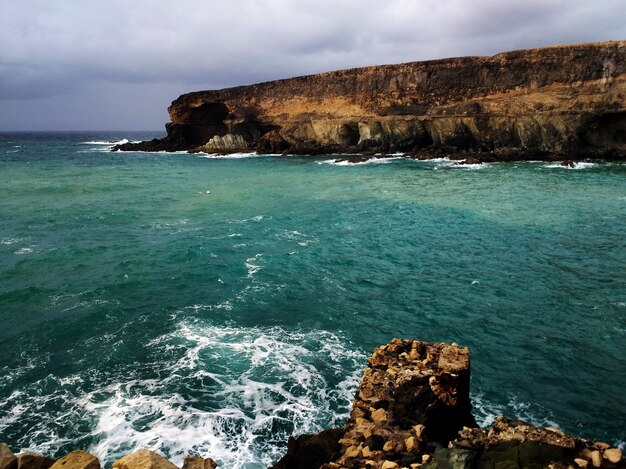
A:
[{"xmin": 0, "ymin": 322, "xmax": 365, "ymax": 468}]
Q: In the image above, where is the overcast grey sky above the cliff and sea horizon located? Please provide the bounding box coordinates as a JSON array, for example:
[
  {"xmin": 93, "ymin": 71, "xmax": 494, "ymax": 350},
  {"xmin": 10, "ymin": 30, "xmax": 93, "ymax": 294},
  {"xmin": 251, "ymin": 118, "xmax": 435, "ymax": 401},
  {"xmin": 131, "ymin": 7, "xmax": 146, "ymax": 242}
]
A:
[{"xmin": 0, "ymin": 0, "xmax": 626, "ymax": 131}]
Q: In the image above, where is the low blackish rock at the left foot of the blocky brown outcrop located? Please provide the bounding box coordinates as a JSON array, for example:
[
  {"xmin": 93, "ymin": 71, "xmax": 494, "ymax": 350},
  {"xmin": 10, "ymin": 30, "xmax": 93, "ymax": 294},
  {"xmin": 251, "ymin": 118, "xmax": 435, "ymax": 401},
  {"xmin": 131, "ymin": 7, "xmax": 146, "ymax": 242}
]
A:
[{"xmin": 272, "ymin": 429, "xmax": 343, "ymax": 469}]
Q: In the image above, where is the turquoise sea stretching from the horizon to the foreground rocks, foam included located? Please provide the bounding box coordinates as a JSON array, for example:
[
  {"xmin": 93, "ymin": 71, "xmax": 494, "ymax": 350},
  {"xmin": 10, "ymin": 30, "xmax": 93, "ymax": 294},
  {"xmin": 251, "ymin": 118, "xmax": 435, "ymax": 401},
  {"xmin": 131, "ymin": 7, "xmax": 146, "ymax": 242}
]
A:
[{"xmin": 0, "ymin": 132, "xmax": 626, "ymax": 468}]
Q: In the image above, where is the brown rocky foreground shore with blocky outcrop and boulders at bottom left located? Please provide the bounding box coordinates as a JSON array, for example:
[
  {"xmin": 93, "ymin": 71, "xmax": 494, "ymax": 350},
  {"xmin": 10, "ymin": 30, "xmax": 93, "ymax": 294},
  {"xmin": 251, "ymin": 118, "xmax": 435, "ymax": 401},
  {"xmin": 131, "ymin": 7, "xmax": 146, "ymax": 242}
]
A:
[{"xmin": 0, "ymin": 339, "xmax": 626, "ymax": 469}]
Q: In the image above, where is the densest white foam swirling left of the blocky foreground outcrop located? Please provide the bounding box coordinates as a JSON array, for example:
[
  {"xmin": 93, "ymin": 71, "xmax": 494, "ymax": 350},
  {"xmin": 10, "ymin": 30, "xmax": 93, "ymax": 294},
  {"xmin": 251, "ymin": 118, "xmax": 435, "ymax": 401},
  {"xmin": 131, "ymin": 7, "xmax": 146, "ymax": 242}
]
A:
[{"xmin": 73, "ymin": 323, "xmax": 365, "ymax": 468}]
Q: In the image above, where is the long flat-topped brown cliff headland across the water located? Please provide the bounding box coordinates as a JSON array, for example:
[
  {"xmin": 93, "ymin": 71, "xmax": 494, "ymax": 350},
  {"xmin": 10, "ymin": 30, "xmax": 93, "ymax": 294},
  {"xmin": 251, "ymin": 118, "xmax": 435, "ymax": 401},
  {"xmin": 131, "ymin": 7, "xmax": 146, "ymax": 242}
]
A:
[{"xmin": 115, "ymin": 41, "xmax": 626, "ymax": 159}]
